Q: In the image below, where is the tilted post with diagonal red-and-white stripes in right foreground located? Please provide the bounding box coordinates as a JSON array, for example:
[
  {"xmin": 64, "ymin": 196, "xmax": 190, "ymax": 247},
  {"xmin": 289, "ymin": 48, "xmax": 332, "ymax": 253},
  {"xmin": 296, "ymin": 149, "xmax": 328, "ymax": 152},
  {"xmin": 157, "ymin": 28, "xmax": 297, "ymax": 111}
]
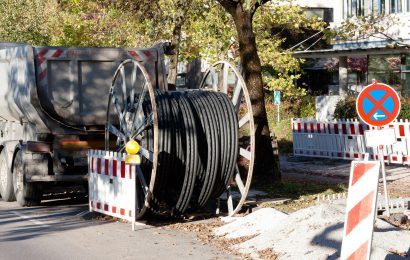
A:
[{"xmin": 341, "ymin": 161, "xmax": 380, "ymax": 260}]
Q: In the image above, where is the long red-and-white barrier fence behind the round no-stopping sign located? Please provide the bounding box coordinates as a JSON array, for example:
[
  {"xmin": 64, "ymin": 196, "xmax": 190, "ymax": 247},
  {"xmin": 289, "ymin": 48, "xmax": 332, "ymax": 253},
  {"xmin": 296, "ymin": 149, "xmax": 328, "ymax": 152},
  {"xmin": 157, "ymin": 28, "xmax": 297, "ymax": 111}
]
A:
[{"xmin": 291, "ymin": 119, "xmax": 410, "ymax": 165}]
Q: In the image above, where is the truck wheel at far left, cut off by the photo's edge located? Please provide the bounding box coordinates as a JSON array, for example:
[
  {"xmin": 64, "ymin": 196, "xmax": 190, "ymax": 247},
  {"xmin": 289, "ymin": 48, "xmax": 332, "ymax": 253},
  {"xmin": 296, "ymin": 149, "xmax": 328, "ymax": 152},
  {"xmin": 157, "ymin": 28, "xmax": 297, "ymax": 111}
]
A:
[{"xmin": 0, "ymin": 148, "xmax": 16, "ymax": 202}]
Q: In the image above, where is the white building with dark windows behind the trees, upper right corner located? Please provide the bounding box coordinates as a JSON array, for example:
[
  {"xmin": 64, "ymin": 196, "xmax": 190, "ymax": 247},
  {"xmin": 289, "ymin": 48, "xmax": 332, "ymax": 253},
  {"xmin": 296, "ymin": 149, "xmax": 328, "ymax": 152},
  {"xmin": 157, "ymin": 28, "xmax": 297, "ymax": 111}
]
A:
[{"xmin": 295, "ymin": 0, "xmax": 410, "ymax": 100}]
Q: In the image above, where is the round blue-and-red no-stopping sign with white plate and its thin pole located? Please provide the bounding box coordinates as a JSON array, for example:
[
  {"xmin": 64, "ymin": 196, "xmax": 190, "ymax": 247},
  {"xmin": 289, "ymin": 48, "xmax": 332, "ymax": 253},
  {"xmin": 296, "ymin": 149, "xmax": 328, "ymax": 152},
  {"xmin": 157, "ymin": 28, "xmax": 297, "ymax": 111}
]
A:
[{"xmin": 356, "ymin": 81, "xmax": 401, "ymax": 216}]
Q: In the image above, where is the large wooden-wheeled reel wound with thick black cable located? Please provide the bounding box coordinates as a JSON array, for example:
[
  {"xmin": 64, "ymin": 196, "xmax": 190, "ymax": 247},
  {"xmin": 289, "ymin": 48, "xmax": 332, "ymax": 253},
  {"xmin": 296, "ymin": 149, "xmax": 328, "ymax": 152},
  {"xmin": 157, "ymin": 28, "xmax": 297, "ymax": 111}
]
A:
[{"xmin": 105, "ymin": 60, "xmax": 255, "ymax": 219}]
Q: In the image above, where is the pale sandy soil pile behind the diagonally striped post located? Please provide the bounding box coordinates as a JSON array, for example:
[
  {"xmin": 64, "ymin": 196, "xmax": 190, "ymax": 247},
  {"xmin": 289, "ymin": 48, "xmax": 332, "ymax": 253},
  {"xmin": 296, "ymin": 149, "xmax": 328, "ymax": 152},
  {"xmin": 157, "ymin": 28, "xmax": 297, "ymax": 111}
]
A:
[{"xmin": 215, "ymin": 204, "xmax": 410, "ymax": 259}]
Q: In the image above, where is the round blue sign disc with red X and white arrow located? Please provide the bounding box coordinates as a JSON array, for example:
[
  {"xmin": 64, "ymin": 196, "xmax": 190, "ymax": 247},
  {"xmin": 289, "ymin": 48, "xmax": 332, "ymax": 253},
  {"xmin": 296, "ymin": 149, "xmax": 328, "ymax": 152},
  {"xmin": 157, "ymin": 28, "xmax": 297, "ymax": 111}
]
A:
[{"xmin": 356, "ymin": 83, "xmax": 400, "ymax": 126}]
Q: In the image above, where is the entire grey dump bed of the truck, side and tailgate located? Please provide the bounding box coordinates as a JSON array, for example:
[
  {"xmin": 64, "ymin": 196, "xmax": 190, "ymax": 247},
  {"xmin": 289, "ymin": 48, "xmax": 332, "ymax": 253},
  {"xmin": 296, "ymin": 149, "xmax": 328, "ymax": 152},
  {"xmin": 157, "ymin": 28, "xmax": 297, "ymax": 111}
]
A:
[{"xmin": 0, "ymin": 43, "xmax": 167, "ymax": 134}]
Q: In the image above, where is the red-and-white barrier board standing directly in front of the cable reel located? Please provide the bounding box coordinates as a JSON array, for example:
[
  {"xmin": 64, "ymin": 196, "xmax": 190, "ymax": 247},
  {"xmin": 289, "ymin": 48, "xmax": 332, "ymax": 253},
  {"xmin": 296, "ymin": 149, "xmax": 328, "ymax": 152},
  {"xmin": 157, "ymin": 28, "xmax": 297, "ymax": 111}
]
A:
[{"xmin": 88, "ymin": 150, "xmax": 137, "ymax": 230}]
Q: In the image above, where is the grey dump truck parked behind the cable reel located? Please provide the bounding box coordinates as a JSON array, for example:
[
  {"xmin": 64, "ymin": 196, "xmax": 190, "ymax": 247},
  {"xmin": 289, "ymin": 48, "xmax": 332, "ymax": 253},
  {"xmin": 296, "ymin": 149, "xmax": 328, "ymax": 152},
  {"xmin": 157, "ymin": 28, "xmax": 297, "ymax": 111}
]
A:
[{"xmin": 0, "ymin": 43, "xmax": 169, "ymax": 206}]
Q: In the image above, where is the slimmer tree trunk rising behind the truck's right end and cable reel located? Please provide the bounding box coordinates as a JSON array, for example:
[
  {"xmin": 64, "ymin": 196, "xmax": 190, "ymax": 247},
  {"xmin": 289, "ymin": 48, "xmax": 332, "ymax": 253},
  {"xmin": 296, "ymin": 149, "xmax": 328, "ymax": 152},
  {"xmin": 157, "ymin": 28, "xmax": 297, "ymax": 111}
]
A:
[{"xmin": 167, "ymin": 4, "xmax": 186, "ymax": 90}]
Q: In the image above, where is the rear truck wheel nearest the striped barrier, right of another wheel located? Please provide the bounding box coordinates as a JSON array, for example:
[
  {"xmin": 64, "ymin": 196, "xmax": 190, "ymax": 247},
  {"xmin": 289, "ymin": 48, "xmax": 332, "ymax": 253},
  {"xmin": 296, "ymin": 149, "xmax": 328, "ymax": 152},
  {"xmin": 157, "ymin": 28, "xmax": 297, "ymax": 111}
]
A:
[{"xmin": 13, "ymin": 150, "xmax": 42, "ymax": 207}]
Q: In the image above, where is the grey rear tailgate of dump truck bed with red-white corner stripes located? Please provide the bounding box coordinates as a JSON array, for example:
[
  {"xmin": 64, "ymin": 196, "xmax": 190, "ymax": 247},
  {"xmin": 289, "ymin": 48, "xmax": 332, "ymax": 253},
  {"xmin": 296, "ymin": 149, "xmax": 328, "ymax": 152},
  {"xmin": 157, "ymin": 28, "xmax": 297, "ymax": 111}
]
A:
[{"xmin": 34, "ymin": 47, "xmax": 167, "ymax": 129}]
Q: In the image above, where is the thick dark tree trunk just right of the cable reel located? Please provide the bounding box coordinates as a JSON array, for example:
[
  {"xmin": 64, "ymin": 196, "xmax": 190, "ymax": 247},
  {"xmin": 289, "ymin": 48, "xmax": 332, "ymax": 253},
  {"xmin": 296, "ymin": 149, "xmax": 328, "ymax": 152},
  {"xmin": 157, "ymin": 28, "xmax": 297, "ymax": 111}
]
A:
[{"xmin": 231, "ymin": 4, "xmax": 280, "ymax": 180}]
